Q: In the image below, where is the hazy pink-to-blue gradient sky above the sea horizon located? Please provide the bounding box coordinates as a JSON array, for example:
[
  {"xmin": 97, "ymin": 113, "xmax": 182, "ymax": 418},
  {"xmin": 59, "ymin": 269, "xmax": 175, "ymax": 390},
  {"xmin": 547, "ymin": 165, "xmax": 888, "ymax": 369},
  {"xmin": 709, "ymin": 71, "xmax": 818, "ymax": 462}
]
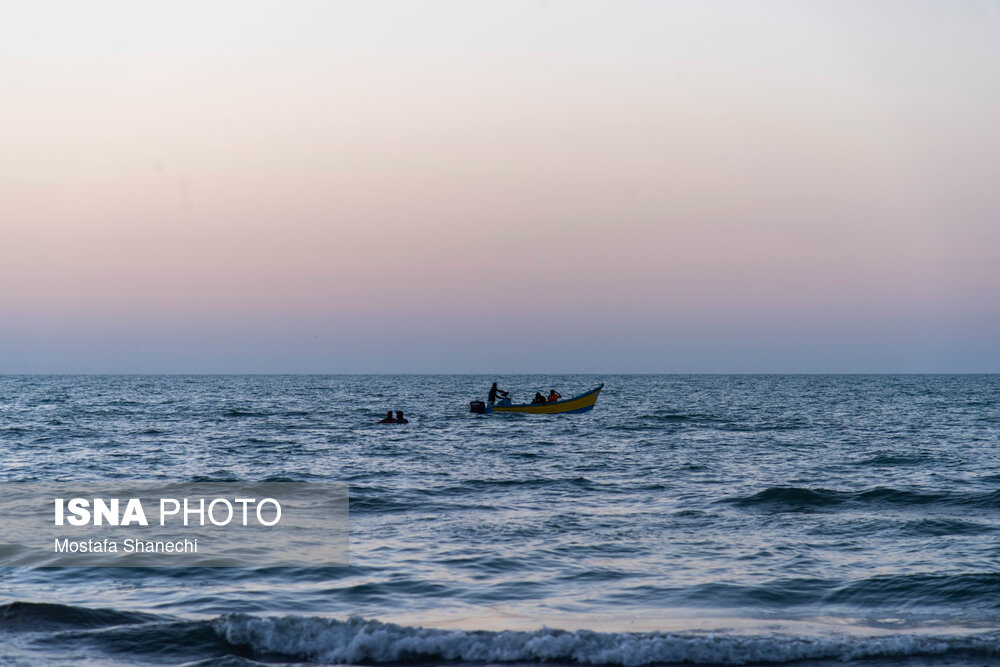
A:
[{"xmin": 0, "ymin": 0, "xmax": 1000, "ymax": 373}]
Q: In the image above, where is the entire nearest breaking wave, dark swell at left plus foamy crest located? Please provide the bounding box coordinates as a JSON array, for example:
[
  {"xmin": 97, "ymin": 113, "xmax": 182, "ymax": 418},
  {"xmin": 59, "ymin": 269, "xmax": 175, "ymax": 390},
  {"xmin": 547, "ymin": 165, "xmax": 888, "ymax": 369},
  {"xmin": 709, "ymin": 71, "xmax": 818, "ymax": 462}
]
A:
[{"xmin": 0, "ymin": 602, "xmax": 1000, "ymax": 667}]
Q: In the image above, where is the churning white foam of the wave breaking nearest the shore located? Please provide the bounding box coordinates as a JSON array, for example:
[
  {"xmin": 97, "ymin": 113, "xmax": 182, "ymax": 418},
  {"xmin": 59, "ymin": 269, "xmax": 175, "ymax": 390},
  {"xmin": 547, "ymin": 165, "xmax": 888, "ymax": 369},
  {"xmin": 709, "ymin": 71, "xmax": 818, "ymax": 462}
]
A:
[{"xmin": 213, "ymin": 615, "xmax": 1000, "ymax": 667}]
